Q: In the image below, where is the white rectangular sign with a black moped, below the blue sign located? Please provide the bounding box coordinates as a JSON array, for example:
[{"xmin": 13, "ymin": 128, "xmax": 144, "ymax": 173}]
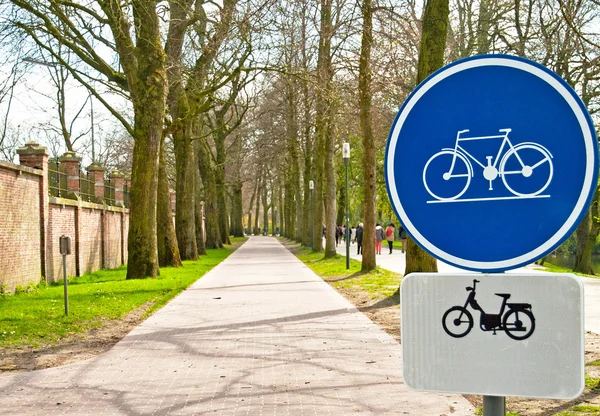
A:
[{"xmin": 400, "ymin": 273, "xmax": 585, "ymax": 399}]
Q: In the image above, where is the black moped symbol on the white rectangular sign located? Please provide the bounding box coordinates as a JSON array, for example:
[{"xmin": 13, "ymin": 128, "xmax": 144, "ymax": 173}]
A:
[{"xmin": 442, "ymin": 280, "xmax": 535, "ymax": 340}]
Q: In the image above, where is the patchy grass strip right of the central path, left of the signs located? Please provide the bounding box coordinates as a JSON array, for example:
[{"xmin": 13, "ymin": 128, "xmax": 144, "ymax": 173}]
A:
[{"xmin": 296, "ymin": 247, "xmax": 402, "ymax": 299}]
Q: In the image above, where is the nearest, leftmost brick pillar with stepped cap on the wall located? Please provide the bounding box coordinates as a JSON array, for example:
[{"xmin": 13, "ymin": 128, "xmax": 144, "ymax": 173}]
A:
[{"xmin": 17, "ymin": 142, "xmax": 48, "ymax": 280}]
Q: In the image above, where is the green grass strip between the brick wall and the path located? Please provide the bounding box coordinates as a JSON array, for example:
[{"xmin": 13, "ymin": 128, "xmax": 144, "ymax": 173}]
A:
[{"xmin": 0, "ymin": 238, "xmax": 245, "ymax": 348}]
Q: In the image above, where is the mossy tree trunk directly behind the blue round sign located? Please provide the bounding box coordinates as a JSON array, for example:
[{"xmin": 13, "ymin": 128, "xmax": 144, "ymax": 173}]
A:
[{"xmin": 404, "ymin": 0, "xmax": 450, "ymax": 275}]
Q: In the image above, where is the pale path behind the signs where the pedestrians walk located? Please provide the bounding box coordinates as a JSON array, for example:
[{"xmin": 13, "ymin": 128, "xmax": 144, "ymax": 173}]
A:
[{"xmin": 336, "ymin": 240, "xmax": 600, "ymax": 334}]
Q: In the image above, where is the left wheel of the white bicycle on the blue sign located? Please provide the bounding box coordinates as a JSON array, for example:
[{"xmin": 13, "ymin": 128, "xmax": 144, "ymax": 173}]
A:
[{"xmin": 423, "ymin": 150, "xmax": 472, "ymax": 201}]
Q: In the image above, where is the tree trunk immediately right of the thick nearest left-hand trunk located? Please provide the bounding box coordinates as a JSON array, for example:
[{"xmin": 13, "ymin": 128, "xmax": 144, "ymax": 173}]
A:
[{"xmin": 156, "ymin": 138, "xmax": 182, "ymax": 267}]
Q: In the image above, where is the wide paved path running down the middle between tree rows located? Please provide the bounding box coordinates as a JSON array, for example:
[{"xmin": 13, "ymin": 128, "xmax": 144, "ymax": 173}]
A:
[{"xmin": 0, "ymin": 237, "xmax": 473, "ymax": 416}]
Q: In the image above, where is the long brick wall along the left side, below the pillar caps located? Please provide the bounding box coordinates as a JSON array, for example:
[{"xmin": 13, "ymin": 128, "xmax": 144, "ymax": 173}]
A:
[{"xmin": 0, "ymin": 154, "xmax": 129, "ymax": 291}]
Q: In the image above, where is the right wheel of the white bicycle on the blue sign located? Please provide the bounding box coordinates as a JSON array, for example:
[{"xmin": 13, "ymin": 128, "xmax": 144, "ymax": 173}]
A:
[{"xmin": 500, "ymin": 143, "xmax": 554, "ymax": 196}]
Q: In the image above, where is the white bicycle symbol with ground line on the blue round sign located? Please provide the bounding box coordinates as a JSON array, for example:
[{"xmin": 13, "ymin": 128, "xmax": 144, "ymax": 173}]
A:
[{"xmin": 423, "ymin": 128, "xmax": 553, "ymax": 203}]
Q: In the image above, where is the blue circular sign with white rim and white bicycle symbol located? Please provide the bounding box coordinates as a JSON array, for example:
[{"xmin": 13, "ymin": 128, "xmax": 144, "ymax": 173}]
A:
[{"xmin": 385, "ymin": 55, "xmax": 598, "ymax": 272}]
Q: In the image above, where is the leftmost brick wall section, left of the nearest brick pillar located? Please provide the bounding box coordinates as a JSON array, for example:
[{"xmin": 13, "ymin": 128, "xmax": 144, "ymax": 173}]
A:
[{"xmin": 0, "ymin": 161, "xmax": 43, "ymax": 290}]
